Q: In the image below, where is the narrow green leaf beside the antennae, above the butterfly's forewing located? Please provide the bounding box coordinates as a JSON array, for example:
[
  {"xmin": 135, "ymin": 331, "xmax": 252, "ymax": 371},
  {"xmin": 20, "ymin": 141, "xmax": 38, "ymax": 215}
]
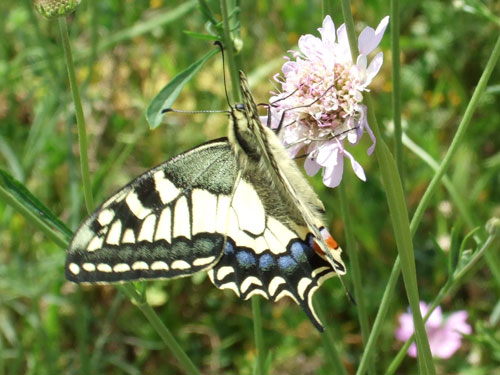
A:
[{"xmin": 146, "ymin": 49, "xmax": 219, "ymax": 129}]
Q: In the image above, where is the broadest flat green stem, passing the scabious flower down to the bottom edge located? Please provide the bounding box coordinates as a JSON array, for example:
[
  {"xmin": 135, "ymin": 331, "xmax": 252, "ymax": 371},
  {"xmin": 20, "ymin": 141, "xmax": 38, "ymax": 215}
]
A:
[{"xmin": 341, "ymin": 0, "xmax": 436, "ymax": 375}]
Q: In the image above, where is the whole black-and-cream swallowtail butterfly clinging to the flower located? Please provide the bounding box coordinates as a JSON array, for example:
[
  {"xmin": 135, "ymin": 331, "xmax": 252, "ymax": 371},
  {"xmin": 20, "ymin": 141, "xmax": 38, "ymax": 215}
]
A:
[{"xmin": 66, "ymin": 73, "xmax": 345, "ymax": 330}]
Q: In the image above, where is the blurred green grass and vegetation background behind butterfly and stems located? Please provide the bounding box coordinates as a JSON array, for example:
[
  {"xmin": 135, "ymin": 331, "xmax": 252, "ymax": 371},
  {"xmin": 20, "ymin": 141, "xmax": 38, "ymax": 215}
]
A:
[{"xmin": 0, "ymin": 0, "xmax": 500, "ymax": 375}]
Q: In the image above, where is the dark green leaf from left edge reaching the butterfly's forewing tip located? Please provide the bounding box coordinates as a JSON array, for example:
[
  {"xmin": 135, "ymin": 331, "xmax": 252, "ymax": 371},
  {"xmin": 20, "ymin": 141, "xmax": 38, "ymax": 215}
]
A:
[{"xmin": 0, "ymin": 169, "xmax": 73, "ymax": 238}]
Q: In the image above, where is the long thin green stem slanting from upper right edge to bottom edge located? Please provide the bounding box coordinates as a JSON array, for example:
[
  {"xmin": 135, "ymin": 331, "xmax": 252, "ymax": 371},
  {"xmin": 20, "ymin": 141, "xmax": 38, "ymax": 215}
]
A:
[{"xmin": 357, "ymin": 37, "xmax": 500, "ymax": 374}]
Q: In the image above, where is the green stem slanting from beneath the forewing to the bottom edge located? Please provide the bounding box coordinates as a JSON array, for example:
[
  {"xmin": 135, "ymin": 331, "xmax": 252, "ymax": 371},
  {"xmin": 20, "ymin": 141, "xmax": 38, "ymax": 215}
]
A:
[{"xmin": 120, "ymin": 284, "xmax": 200, "ymax": 375}]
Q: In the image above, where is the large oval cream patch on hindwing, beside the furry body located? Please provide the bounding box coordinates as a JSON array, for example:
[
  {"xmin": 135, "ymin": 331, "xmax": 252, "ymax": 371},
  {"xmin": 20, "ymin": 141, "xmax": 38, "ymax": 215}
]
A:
[{"xmin": 232, "ymin": 180, "xmax": 266, "ymax": 235}]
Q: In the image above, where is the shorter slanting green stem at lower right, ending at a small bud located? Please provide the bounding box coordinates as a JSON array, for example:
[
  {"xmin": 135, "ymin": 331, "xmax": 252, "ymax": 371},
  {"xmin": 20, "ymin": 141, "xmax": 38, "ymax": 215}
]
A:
[{"xmin": 386, "ymin": 235, "xmax": 496, "ymax": 375}]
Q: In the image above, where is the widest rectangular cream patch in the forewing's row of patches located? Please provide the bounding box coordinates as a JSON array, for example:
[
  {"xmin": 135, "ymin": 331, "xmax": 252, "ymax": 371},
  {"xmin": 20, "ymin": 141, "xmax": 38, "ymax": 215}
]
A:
[{"xmin": 191, "ymin": 189, "xmax": 217, "ymax": 235}]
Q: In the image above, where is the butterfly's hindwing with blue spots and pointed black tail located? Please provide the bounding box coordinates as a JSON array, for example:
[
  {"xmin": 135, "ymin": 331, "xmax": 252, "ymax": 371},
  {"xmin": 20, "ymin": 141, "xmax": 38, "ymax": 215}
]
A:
[{"xmin": 209, "ymin": 176, "xmax": 335, "ymax": 330}]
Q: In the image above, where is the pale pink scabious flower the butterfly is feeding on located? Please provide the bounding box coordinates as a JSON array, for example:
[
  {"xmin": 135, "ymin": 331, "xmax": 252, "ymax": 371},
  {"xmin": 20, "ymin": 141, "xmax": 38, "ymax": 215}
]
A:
[{"xmin": 270, "ymin": 16, "xmax": 389, "ymax": 187}]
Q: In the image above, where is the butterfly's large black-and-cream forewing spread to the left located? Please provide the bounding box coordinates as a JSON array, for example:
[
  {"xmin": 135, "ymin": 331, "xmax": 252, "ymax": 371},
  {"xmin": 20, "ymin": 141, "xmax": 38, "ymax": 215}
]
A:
[{"xmin": 66, "ymin": 139, "xmax": 236, "ymax": 283}]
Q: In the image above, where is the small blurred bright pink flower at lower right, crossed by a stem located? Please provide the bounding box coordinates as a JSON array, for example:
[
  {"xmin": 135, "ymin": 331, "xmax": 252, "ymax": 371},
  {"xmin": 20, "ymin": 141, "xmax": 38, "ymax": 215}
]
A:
[{"xmin": 395, "ymin": 302, "xmax": 472, "ymax": 359}]
